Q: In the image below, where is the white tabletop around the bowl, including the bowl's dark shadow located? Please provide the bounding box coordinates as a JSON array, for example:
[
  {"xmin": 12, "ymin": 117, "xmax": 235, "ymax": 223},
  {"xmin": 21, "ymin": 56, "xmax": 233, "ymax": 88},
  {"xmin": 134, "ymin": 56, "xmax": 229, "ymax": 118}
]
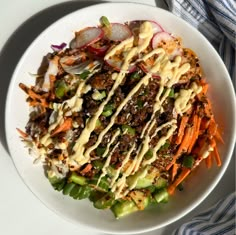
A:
[{"xmin": 0, "ymin": 0, "xmax": 235, "ymax": 235}]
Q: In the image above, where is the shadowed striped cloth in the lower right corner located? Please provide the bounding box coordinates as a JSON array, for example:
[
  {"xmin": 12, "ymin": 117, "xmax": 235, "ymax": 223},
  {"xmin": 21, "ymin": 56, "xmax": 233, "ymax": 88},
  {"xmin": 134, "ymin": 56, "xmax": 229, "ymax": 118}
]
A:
[{"xmin": 173, "ymin": 193, "xmax": 236, "ymax": 235}]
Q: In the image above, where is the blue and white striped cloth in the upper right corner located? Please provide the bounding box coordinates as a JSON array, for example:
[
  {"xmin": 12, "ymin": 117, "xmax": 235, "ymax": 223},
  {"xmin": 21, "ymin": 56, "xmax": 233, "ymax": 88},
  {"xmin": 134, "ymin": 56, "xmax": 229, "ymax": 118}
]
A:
[{"xmin": 165, "ymin": 0, "xmax": 236, "ymax": 81}]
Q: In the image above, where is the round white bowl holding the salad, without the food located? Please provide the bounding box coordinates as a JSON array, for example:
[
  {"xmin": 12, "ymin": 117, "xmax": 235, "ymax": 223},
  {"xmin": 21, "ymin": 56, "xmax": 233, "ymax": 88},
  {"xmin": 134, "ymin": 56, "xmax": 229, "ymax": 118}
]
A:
[{"xmin": 6, "ymin": 3, "xmax": 236, "ymax": 234}]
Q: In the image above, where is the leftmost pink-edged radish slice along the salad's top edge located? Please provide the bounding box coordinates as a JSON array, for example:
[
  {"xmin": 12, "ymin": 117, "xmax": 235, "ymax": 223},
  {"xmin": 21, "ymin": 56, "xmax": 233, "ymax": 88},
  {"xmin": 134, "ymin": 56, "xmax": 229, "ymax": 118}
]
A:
[{"xmin": 74, "ymin": 27, "xmax": 104, "ymax": 48}]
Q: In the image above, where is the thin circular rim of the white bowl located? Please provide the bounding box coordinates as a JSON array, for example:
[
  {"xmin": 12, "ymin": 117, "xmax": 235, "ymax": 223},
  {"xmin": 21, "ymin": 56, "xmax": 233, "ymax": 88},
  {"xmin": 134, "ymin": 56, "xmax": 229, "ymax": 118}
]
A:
[{"xmin": 5, "ymin": 2, "xmax": 236, "ymax": 234}]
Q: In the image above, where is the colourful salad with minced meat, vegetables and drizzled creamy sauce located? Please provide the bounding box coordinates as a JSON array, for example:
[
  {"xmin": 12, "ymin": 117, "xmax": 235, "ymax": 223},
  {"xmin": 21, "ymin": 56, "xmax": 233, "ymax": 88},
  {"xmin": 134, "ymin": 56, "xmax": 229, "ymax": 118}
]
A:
[{"xmin": 17, "ymin": 16, "xmax": 224, "ymax": 219}]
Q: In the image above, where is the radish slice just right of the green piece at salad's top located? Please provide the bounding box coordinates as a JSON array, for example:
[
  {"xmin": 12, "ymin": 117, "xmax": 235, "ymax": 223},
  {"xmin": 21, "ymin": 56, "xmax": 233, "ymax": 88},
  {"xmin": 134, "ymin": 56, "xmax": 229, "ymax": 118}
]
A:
[{"xmin": 106, "ymin": 23, "xmax": 132, "ymax": 42}]
